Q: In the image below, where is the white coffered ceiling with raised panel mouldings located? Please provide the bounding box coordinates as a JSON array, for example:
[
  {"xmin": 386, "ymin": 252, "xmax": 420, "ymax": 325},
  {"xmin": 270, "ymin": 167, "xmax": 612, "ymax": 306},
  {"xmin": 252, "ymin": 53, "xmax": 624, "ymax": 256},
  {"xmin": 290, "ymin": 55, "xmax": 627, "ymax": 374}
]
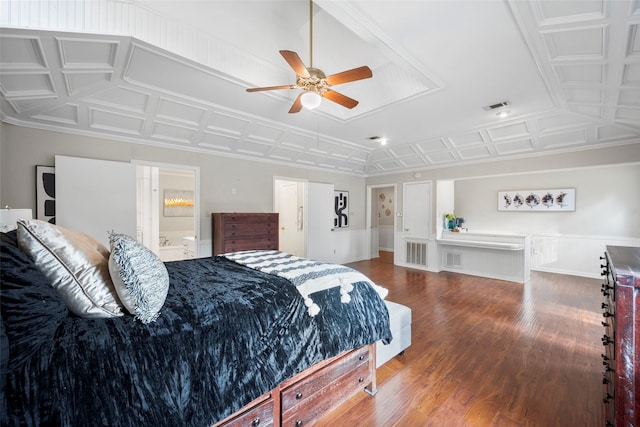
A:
[{"xmin": 0, "ymin": 0, "xmax": 640, "ymax": 176}]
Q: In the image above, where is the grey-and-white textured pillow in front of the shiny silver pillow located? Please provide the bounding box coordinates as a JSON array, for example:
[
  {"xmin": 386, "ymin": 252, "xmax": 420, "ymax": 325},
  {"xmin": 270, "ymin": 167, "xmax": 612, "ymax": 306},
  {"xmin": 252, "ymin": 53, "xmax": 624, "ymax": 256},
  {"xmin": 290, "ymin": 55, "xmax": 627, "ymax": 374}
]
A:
[{"xmin": 109, "ymin": 233, "xmax": 169, "ymax": 323}]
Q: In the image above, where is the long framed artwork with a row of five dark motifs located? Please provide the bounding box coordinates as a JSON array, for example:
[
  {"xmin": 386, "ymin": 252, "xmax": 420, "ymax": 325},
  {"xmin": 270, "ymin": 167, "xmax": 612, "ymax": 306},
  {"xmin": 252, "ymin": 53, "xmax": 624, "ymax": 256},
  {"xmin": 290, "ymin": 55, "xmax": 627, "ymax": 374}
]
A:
[{"xmin": 498, "ymin": 188, "xmax": 576, "ymax": 212}]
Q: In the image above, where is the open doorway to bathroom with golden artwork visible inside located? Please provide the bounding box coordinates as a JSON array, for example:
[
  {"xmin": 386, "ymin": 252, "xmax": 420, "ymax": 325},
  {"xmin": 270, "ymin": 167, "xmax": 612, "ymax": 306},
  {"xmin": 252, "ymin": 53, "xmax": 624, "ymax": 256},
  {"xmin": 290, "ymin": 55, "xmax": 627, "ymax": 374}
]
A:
[{"xmin": 136, "ymin": 163, "xmax": 200, "ymax": 261}]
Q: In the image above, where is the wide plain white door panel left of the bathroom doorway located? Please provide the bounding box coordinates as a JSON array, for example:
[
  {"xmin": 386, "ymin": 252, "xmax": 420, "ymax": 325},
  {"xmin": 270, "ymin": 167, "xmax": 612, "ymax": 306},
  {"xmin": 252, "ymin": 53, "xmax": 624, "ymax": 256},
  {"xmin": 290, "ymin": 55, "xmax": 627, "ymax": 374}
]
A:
[{"xmin": 56, "ymin": 156, "xmax": 136, "ymax": 248}]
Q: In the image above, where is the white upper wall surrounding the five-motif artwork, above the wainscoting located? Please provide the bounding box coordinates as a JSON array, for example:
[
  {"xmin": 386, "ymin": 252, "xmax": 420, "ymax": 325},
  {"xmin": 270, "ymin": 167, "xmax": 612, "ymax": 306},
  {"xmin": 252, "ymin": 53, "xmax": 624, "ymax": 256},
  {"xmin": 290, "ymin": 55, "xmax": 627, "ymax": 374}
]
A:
[{"xmin": 455, "ymin": 163, "xmax": 640, "ymax": 237}]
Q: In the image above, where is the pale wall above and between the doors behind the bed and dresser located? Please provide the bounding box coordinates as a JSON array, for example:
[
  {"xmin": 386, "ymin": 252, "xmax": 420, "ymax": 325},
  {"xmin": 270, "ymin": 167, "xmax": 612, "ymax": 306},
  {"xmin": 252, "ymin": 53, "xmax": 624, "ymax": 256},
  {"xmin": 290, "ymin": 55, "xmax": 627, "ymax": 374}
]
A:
[{"xmin": 0, "ymin": 123, "xmax": 367, "ymax": 254}]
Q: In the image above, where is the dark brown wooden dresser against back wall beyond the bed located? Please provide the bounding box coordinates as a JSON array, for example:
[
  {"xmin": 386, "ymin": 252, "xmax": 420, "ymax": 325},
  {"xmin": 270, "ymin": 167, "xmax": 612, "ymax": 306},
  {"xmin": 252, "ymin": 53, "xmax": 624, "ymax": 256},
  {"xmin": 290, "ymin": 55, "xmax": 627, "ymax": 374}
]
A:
[{"xmin": 211, "ymin": 213, "xmax": 279, "ymax": 256}]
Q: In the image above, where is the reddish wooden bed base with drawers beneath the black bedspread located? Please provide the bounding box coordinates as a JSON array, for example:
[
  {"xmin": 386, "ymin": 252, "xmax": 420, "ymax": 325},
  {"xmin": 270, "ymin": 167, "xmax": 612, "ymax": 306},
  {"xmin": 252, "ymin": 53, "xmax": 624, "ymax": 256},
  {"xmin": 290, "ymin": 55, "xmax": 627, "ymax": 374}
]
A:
[{"xmin": 214, "ymin": 344, "xmax": 377, "ymax": 427}]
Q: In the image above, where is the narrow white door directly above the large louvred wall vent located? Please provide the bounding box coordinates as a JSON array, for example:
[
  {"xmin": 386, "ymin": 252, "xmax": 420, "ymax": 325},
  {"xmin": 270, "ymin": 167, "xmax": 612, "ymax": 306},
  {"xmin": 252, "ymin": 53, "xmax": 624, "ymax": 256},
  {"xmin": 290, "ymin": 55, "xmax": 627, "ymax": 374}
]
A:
[{"xmin": 403, "ymin": 182, "xmax": 431, "ymax": 239}]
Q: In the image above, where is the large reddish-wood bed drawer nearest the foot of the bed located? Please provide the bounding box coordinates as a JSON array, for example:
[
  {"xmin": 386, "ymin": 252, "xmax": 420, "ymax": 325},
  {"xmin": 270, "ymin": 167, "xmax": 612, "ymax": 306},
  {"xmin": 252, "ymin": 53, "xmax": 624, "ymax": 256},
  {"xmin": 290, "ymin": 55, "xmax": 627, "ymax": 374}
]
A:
[{"xmin": 280, "ymin": 347, "xmax": 371, "ymax": 427}]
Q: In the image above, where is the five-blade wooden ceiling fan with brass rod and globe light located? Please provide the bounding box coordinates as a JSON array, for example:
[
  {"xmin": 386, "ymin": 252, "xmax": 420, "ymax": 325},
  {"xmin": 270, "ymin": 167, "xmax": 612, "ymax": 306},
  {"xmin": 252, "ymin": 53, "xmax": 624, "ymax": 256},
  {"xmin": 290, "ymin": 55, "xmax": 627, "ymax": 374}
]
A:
[{"xmin": 247, "ymin": 0, "xmax": 373, "ymax": 113}]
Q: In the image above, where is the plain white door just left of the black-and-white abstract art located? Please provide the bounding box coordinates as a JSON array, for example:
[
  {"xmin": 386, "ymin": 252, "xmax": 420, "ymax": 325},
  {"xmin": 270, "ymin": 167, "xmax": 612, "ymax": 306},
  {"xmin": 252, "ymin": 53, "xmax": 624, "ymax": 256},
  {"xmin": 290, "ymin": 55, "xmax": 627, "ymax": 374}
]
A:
[{"xmin": 305, "ymin": 182, "xmax": 335, "ymax": 262}]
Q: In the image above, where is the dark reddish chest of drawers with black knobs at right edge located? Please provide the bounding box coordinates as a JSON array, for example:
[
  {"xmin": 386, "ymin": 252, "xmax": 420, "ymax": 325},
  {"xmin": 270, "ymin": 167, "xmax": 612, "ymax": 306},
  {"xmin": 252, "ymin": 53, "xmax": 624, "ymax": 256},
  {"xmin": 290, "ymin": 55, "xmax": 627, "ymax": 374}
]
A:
[{"xmin": 601, "ymin": 246, "xmax": 640, "ymax": 427}]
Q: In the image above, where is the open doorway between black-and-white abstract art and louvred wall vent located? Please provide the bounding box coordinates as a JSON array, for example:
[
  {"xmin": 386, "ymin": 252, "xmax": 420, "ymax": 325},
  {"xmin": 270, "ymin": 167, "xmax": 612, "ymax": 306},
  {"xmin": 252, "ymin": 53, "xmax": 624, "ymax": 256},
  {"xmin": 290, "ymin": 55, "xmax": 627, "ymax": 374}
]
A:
[{"xmin": 367, "ymin": 184, "xmax": 397, "ymax": 258}]
